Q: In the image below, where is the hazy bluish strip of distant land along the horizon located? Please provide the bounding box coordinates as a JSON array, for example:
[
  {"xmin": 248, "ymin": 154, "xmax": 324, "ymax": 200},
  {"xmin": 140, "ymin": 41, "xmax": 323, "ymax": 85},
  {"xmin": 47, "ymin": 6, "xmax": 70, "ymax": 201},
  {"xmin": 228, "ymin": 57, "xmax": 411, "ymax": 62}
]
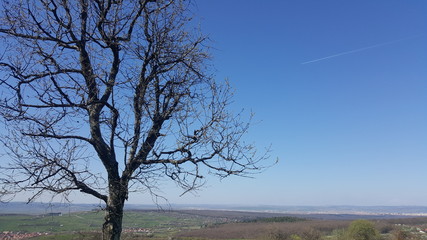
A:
[{"xmin": 4, "ymin": 202, "xmax": 427, "ymax": 217}]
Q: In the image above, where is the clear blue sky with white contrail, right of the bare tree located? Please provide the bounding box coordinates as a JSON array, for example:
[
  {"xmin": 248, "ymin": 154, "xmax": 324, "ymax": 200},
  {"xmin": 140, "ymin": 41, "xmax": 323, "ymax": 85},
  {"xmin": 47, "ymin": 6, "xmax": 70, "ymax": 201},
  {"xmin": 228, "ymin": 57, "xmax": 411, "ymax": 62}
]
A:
[{"xmin": 153, "ymin": 0, "xmax": 427, "ymax": 205}]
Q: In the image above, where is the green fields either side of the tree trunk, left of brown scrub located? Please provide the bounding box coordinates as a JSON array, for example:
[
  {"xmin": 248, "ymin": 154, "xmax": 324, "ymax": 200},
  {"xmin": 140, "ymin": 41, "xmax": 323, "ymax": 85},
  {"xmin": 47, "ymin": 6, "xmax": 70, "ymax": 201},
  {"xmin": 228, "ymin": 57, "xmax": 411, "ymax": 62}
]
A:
[{"xmin": 0, "ymin": 211, "xmax": 219, "ymax": 239}]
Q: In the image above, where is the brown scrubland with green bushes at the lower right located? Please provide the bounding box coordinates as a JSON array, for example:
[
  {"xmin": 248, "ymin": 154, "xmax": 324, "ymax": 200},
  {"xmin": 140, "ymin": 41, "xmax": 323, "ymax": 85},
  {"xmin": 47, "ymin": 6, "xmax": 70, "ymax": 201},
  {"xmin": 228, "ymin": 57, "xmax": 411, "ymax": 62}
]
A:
[{"xmin": 177, "ymin": 218, "xmax": 427, "ymax": 240}]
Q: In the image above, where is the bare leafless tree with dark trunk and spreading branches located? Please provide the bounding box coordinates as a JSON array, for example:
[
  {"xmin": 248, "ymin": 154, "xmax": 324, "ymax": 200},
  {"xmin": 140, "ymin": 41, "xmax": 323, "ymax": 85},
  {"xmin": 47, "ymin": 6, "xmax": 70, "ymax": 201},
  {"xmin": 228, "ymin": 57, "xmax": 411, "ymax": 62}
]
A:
[{"xmin": 0, "ymin": 0, "xmax": 265, "ymax": 239}]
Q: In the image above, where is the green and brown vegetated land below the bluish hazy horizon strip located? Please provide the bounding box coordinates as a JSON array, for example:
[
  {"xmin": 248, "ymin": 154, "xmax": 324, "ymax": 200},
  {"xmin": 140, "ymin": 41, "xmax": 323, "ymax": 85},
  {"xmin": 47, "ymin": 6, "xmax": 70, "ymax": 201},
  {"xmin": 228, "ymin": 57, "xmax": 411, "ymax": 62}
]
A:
[{"xmin": 0, "ymin": 211, "xmax": 427, "ymax": 240}]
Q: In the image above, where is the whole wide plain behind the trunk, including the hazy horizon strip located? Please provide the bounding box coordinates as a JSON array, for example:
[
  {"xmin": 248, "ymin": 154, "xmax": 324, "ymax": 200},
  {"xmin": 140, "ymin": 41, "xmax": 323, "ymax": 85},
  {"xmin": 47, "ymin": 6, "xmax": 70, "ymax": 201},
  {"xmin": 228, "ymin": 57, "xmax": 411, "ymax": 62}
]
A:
[{"xmin": 0, "ymin": 203, "xmax": 427, "ymax": 240}]
